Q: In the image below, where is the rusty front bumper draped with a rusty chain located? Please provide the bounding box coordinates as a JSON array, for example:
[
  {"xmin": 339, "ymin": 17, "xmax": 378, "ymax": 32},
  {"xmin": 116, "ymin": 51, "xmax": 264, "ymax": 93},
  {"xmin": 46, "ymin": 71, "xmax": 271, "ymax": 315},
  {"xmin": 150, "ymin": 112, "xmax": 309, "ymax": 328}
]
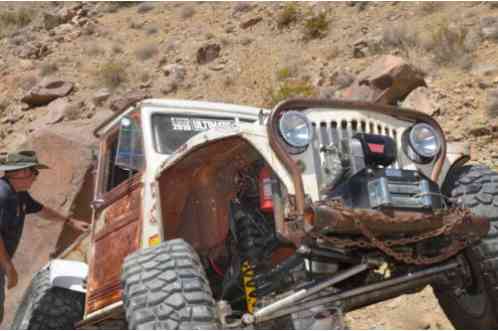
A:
[{"xmin": 305, "ymin": 203, "xmax": 489, "ymax": 238}]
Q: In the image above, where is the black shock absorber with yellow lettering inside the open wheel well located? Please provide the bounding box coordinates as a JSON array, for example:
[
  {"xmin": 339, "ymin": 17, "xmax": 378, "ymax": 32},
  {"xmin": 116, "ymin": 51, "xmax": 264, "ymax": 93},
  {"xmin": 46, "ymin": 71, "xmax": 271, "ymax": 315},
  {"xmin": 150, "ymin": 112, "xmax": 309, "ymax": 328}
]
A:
[{"xmin": 233, "ymin": 203, "xmax": 273, "ymax": 313}]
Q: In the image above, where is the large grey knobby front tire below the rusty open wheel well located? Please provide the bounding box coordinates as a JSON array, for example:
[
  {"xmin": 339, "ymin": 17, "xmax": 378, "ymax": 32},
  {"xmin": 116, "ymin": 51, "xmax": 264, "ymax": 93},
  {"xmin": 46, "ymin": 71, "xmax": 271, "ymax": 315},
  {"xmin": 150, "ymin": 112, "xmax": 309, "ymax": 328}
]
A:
[{"xmin": 121, "ymin": 239, "xmax": 219, "ymax": 330}]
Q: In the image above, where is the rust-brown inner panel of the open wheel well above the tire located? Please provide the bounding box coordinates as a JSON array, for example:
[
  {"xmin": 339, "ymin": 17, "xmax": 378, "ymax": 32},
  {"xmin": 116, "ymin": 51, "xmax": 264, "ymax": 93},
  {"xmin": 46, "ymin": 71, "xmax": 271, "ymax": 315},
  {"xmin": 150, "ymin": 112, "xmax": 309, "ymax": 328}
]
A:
[{"xmin": 159, "ymin": 137, "xmax": 259, "ymax": 251}]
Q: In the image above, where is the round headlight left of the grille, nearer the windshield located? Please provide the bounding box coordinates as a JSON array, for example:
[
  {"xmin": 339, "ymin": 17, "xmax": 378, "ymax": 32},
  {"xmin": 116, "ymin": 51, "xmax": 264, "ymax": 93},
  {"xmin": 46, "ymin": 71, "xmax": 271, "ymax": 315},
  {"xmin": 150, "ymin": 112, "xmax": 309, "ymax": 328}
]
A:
[{"xmin": 278, "ymin": 111, "xmax": 313, "ymax": 148}]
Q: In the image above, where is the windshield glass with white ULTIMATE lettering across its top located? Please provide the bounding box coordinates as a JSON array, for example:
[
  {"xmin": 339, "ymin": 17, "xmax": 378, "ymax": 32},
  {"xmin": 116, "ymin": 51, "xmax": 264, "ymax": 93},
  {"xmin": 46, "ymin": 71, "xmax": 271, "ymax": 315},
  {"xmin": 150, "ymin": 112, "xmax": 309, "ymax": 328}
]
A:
[{"xmin": 152, "ymin": 114, "xmax": 244, "ymax": 154}]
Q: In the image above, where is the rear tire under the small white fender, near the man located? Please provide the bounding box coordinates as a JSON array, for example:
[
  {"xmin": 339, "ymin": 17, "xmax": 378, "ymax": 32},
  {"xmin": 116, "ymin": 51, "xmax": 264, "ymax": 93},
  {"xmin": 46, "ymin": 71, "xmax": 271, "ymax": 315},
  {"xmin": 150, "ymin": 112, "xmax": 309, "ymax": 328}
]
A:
[{"xmin": 10, "ymin": 267, "xmax": 85, "ymax": 330}]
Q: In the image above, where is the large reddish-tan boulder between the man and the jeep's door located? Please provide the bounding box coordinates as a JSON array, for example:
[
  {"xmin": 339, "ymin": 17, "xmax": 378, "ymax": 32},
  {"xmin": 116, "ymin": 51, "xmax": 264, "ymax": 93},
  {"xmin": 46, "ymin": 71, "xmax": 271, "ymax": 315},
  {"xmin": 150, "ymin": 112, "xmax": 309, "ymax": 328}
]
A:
[{"xmin": 0, "ymin": 111, "xmax": 110, "ymax": 329}]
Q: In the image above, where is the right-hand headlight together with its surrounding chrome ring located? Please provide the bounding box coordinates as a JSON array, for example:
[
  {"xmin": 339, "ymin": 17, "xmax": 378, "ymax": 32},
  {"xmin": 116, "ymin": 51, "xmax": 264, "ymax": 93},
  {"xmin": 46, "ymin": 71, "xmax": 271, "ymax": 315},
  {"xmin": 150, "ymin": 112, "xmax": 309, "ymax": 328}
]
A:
[{"xmin": 403, "ymin": 122, "xmax": 442, "ymax": 164}]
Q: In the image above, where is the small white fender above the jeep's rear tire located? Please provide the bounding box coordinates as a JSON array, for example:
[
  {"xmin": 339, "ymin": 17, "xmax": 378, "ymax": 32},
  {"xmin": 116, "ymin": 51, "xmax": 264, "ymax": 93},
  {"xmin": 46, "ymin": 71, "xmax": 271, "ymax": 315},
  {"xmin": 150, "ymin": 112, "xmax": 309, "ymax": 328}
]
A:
[{"xmin": 48, "ymin": 260, "xmax": 88, "ymax": 293}]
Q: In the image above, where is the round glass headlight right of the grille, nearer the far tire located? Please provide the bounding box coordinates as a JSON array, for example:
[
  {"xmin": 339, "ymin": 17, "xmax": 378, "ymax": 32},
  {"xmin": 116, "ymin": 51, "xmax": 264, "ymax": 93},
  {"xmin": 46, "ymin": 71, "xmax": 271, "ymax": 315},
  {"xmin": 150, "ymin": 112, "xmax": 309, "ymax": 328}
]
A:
[{"xmin": 409, "ymin": 123, "xmax": 441, "ymax": 158}]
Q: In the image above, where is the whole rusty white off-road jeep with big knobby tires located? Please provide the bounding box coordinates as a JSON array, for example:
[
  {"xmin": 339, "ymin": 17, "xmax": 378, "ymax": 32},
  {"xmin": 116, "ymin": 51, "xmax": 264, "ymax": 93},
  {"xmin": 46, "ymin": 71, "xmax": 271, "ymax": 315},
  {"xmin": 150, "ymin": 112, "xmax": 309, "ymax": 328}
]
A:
[{"xmin": 13, "ymin": 99, "xmax": 498, "ymax": 329}]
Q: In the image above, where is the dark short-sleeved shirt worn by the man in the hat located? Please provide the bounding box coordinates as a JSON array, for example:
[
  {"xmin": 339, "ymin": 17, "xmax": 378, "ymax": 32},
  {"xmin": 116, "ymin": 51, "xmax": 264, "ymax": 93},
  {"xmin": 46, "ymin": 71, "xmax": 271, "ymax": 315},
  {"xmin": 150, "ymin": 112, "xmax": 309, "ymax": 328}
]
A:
[{"xmin": 0, "ymin": 177, "xmax": 43, "ymax": 258}]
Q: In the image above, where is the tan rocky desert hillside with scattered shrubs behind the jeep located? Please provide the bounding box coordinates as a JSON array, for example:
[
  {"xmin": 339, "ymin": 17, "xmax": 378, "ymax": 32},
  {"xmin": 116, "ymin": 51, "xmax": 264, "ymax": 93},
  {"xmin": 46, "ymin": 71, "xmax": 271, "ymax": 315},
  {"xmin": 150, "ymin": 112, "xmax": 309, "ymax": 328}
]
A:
[{"xmin": 0, "ymin": 2, "xmax": 498, "ymax": 329}]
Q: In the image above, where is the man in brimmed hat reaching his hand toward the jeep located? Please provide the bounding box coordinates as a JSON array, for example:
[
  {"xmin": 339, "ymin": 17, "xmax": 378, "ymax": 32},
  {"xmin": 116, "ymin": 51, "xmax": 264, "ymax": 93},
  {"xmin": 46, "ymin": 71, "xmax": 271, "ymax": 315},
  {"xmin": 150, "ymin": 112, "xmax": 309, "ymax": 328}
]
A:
[{"xmin": 0, "ymin": 151, "xmax": 88, "ymax": 322}]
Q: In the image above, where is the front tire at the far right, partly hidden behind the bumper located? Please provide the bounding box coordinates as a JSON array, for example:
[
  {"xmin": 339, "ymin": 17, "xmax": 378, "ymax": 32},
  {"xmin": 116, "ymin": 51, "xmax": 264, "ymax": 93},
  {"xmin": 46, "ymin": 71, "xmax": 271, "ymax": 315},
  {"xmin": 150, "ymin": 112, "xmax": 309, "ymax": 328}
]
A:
[{"xmin": 434, "ymin": 165, "xmax": 498, "ymax": 329}]
